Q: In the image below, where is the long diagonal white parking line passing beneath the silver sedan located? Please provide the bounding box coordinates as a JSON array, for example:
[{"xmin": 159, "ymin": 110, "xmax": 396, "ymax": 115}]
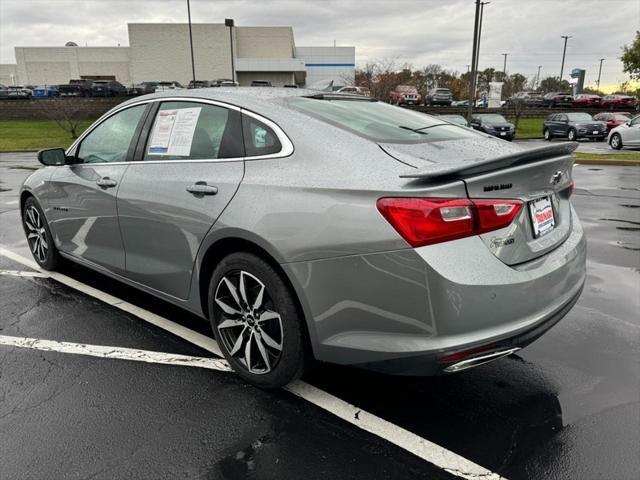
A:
[{"xmin": 0, "ymin": 246, "xmax": 504, "ymax": 480}]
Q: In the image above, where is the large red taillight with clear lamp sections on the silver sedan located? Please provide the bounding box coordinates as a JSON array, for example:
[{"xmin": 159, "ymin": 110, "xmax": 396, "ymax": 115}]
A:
[{"xmin": 377, "ymin": 197, "xmax": 522, "ymax": 247}]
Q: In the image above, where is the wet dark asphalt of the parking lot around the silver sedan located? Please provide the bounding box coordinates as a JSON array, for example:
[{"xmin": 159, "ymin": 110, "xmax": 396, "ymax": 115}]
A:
[{"xmin": 0, "ymin": 154, "xmax": 640, "ymax": 479}]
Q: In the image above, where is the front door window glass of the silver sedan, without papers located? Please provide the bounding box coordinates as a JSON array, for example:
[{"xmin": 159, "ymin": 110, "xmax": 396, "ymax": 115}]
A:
[{"xmin": 76, "ymin": 105, "xmax": 147, "ymax": 163}]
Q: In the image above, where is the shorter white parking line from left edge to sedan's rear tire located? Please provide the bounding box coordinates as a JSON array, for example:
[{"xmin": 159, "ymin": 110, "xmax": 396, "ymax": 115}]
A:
[{"xmin": 0, "ymin": 335, "xmax": 231, "ymax": 372}]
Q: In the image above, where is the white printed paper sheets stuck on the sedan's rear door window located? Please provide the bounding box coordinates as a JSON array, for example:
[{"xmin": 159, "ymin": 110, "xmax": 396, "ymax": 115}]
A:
[{"xmin": 147, "ymin": 107, "xmax": 202, "ymax": 157}]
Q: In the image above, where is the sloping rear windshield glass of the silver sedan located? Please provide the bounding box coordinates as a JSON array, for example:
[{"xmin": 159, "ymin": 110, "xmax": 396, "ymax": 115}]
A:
[{"xmin": 285, "ymin": 97, "xmax": 477, "ymax": 143}]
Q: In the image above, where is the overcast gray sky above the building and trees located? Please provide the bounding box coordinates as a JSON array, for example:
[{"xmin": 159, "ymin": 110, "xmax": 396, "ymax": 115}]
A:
[{"xmin": 0, "ymin": 0, "xmax": 640, "ymax": 86}]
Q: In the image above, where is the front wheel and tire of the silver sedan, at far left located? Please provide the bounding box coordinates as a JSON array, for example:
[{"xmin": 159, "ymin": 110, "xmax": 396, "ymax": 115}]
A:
[{"xmin": 22, "ymin": 197, "xmax": 60, "ymax": 270}]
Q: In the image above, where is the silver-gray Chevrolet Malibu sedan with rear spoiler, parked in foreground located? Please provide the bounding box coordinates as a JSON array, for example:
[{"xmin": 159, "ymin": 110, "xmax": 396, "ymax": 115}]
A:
[{"xmin": 20, "ymin": 88, "xmax": 586, "ymax": 388}]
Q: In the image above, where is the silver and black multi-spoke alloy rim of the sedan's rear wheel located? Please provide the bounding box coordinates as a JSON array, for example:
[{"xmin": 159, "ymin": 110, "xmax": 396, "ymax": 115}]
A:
[{"xmin": 214, "ymin": 270, "xmax": 284, "ymax": 375}]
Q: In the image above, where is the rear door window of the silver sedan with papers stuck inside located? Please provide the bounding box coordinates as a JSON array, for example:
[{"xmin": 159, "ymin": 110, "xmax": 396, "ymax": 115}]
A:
[{"xmin": 144, "ymin": 102, "xmax": 244, "ymax": 160}]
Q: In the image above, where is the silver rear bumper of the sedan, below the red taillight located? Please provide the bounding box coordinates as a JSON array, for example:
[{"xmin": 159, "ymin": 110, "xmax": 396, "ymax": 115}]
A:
[{"xmin": 282, "ymin": 206, "xmax": 586, "ymax": 375}]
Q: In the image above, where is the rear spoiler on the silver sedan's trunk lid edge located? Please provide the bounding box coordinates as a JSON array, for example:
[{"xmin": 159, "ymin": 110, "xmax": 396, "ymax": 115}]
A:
[{"xmin": 400, "ymin": 142, "xmax": 578, "ymax": 180}]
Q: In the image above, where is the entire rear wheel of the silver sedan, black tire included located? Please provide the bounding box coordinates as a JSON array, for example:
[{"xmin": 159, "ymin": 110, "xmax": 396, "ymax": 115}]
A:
[{"xmin": 208, "ymin": 252, "xmax": 311, "ymax": 389}]
